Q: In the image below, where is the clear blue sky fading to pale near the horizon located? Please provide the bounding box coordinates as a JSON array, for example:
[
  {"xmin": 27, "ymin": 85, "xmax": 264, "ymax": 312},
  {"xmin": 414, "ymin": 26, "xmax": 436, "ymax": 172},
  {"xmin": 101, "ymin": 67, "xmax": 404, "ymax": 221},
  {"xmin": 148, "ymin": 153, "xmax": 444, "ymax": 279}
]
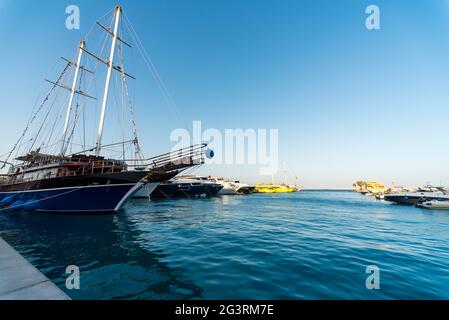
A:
[{"xmin": 0, "ymin": 0, "xmax": 449, "ymax": 187}]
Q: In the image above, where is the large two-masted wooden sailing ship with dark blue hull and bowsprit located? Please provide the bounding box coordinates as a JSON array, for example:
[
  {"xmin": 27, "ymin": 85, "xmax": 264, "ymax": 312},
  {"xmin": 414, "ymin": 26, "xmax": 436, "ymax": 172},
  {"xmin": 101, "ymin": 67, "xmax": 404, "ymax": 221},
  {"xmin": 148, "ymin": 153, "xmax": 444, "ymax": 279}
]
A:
[{"xmin": 0, "ymin": 6, "xmax": 206, "ymax": 213}]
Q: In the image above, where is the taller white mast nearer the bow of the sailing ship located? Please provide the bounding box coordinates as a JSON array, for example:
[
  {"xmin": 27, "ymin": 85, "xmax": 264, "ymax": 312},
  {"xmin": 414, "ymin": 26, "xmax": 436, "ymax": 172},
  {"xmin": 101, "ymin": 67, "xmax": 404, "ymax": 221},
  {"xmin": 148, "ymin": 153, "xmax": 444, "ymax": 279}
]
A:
[{"xmin": 95, "ymin": 6, "xmax": 122, "ymax": 156}]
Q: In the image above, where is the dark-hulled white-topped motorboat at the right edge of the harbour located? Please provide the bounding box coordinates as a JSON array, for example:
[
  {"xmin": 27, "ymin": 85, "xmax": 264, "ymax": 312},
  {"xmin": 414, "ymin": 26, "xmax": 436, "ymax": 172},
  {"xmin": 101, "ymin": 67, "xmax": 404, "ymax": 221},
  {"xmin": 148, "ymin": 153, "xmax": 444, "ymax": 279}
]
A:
[{"xmin": 384, "ymin": 186, "xmax": 449, "ymax": 205}]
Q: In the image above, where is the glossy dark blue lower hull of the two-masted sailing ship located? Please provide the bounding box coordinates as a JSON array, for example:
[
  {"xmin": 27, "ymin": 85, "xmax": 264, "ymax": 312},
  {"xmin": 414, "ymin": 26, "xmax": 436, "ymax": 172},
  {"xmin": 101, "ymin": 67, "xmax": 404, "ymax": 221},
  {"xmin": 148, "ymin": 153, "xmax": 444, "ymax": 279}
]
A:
[{"xmin": 0, "ymin": 183, "xmax": 138, "ymax": 213}]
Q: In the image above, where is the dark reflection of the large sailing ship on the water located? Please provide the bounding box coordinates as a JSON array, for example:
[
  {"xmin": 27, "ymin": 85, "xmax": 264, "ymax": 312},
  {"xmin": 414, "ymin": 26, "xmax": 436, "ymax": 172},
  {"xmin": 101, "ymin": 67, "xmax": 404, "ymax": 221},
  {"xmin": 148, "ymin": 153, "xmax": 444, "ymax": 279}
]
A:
[{"xmin": 0, "ymin": 211, "xmax": 202, "ymax": 299}]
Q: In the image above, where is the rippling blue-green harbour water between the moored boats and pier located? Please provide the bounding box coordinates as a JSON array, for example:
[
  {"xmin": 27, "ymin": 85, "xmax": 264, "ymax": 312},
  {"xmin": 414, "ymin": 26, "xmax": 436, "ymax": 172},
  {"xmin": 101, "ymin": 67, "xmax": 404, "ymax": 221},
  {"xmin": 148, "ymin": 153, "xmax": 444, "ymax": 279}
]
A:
[{"xmin": 0, "ymin": 191, "xmax": 449, "ymax": 299}]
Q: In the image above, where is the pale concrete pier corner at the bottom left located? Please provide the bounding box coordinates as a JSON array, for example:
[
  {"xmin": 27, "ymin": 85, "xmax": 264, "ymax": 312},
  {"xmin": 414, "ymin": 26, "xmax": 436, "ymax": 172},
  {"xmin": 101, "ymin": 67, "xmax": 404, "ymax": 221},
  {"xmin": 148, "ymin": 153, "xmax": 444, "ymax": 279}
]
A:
[{"xmin": 0, "ymin": 238, "xmax": 70, "ymax": 300}]
